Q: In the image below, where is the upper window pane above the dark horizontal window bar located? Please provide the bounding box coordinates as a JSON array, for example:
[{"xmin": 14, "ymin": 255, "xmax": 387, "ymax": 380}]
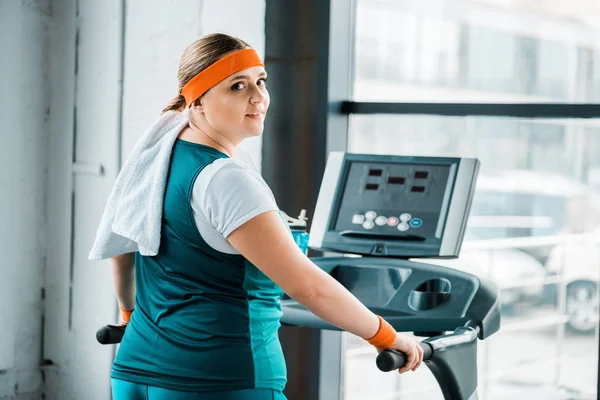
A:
[{"xmin": 354, "ymin": 0, "xmax": 600, "ymax": 102}]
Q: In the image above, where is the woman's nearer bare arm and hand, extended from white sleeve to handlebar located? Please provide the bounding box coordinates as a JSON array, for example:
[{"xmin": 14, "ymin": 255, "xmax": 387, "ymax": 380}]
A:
[{"xmin": 227, "ymin": 211, "xmax": 423, "ymax": 373}]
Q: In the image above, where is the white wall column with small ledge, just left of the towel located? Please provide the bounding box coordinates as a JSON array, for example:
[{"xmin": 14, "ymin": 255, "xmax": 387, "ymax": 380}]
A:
[{"xmin": 59, "ymin": 0, "xmax": 123, "ymax": 400}]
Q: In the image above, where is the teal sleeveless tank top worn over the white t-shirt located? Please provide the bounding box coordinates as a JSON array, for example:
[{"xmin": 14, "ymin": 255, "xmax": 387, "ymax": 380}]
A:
[{"xmin": 111, "ymin": 140, "xmax": 286, "ymax": 392}]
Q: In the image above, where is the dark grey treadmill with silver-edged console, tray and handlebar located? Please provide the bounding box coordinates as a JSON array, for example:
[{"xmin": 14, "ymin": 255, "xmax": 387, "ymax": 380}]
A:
[{"xmin": 281, "ymin": 152, "xmax": 500, "ymax": 400}]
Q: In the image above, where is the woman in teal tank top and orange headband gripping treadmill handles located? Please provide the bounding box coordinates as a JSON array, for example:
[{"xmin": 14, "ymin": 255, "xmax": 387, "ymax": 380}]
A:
[{"xmin": 111, "ymin": 34, "xmax": 422, "ymax": 400}]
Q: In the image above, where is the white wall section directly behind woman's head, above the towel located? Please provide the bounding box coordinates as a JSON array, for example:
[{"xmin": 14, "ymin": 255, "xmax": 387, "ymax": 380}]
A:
[{"xmin": 123, "ymin": 0, "xmax": 204, "ymax": 160}]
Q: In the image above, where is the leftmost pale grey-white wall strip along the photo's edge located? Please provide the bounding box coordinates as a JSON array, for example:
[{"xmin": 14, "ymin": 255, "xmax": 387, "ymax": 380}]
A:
[{"xmin": 0, "ymin": 0, "xmax": 49, "ymax": 398}]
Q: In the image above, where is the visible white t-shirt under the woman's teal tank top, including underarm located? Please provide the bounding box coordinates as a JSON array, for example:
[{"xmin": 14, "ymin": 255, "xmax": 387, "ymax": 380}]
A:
[{"xmin": 191, "ymin": 158, "xmax": 279, "ymax": 254}]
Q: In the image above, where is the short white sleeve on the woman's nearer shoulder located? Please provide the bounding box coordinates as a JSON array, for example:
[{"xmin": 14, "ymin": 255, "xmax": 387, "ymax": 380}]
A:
[{"xmin": 194, "ymin": 160, "xmax": 278, "ymax": 238}]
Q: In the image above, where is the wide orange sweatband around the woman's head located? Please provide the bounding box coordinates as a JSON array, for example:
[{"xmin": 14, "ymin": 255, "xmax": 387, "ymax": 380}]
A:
[{"xmin": 181, "ymin": 49, "xmax": 264, "ymax": 107}]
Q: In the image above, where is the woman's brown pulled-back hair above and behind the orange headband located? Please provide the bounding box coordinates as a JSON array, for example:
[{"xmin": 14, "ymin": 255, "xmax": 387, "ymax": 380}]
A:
[{"xmin": 162, "ymin": 33, "xmax": 250, "ymax": 113}]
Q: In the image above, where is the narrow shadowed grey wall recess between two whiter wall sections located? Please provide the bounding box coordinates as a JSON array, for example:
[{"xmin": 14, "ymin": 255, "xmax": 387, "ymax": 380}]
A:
[{"xmin": 42, "ymin": 0, "xmax": 77, "ymax": 398}]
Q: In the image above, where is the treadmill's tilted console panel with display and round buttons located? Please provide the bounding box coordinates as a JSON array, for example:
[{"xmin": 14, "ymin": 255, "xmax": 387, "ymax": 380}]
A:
[{"xmin": 309, "ymin": 152, "xmax": 479, "ymax": 258}]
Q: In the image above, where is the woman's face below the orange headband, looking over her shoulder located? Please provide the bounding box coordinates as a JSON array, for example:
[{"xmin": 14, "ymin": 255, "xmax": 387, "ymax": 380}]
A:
[{"xmin": 192, "ymin": 66, "xmax": 269, "ymax": 142}]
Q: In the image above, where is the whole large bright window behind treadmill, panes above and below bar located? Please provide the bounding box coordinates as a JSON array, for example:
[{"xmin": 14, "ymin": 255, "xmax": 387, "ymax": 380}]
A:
[{"xmin": 343, "ymin": 0, "xmax": 600, "ymax": 400}]
